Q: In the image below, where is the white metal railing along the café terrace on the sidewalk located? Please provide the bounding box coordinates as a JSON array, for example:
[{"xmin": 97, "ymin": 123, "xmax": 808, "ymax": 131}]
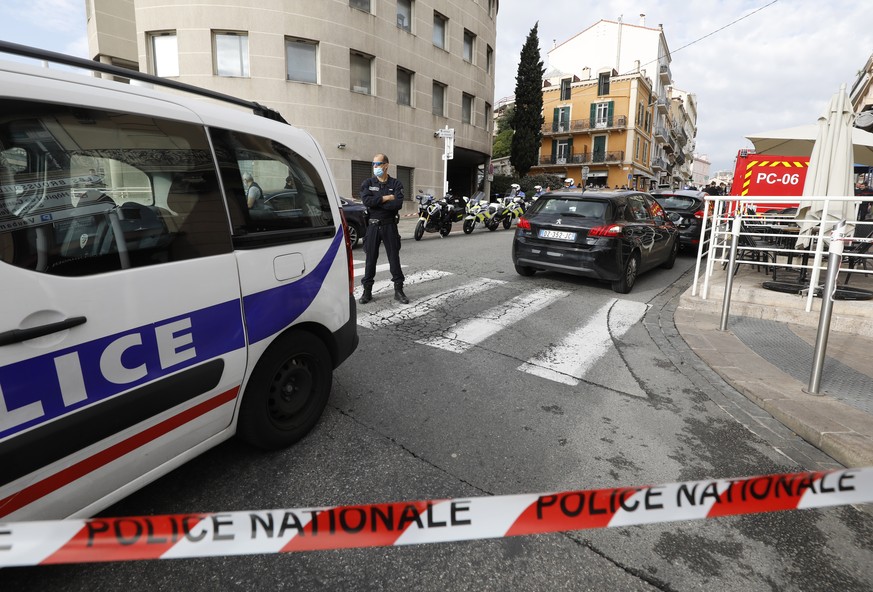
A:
[{"xmin": 691, "ymin": 196, "xmax": 873, "ymax": 312}]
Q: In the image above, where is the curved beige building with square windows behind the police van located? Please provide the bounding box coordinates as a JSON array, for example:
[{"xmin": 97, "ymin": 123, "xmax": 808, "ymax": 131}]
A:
[{"xmin": 85, "ymin": 0, "xmax": 499, "ymax": 207}]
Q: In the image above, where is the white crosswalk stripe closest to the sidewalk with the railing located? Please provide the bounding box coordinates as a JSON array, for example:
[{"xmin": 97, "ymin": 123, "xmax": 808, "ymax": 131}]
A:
[{"xmin": 518, "ymin": 298, "xmax": 648, "ymax": 386}]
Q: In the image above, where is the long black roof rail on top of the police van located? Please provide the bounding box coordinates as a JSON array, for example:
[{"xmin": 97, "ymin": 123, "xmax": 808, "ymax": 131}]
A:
[{"xmin": 0, "ymin": 40, "xmax": 288, "ymax": 123}]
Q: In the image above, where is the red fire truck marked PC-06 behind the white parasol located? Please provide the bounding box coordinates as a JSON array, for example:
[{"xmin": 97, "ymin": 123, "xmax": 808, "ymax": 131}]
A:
[{"xmin": 730, "ymin": 150, "xmax": 809, "ymax": 214}]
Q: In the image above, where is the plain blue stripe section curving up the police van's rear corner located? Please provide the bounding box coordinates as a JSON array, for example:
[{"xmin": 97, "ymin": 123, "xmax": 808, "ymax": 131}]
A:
[{"xmin": 243, "ymin": 226, "xmax": 345, "ymax": 343}]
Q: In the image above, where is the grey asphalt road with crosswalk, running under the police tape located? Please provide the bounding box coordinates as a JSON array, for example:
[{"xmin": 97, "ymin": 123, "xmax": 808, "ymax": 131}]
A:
[{"xmin": 0, "ymin": 224, "xmax": 873, "ymax": 592}]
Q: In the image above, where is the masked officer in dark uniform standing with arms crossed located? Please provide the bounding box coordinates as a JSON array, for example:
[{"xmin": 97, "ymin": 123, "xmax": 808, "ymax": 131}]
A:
[{"xmin": 358, "ymin": 154, "xmax": 409, "ymax": 304}]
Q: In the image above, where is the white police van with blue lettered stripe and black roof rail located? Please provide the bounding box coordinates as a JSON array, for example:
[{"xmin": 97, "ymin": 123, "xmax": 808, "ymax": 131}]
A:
[{"xmin": 0, "ymin": 42, "xmax": 358, "ymax": 520}]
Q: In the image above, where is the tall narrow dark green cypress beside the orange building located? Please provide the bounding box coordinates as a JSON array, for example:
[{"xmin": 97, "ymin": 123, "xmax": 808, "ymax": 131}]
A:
[{"xmin": 509, "ymin": 22, "xmax": 546, "ymax": 177}]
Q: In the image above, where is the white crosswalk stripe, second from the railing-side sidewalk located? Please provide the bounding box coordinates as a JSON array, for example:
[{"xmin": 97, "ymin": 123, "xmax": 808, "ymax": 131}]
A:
[{"xmin": 416, "ymin": 288, "xmax": 569, "ymax": 354}]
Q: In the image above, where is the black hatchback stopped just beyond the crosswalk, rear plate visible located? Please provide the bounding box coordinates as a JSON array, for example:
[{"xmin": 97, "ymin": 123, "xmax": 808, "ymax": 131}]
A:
[{"xmin": 512, "ymin": 190, "xmax": 679, "ymax": 294}]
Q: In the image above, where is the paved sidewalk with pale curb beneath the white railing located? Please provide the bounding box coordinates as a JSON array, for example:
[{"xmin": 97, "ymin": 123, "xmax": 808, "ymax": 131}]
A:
[{"xmin": 674, "ymin": 266, "xmax": 873, "ymax": 467}]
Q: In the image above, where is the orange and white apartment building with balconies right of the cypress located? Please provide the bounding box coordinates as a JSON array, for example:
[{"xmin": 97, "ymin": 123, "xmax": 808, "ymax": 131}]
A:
[{"xmin": 537, "ymin": 15, "xmax": 697, "ymax": 189}]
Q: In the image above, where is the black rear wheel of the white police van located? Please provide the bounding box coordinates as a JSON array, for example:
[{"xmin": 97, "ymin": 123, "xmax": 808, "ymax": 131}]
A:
[{"xmin": 237, "ymin": 331, "xmax": 333, "ymax": 450}]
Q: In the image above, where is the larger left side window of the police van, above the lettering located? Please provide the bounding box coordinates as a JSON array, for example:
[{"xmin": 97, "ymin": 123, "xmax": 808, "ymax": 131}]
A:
[{"xmin": 0, "ymin": 100, "xmax": 232, "ymax": 276}]
